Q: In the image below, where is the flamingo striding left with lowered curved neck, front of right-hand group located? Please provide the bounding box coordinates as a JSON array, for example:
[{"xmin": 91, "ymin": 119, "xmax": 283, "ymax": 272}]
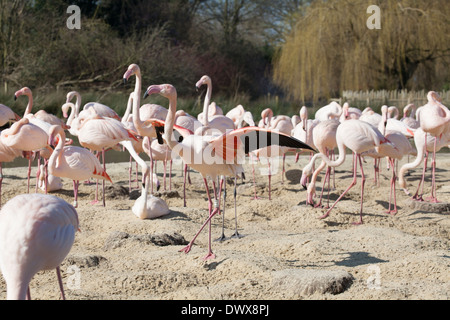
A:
[{"xmin": 303, "ymin": 119, "xmax": 389, "ymax": 224}]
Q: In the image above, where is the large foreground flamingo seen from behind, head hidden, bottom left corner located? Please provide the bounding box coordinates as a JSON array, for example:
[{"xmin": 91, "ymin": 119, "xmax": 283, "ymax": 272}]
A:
[{"xmin": 0, "ymin": 194, "xmax": 79, "ymax": 300}]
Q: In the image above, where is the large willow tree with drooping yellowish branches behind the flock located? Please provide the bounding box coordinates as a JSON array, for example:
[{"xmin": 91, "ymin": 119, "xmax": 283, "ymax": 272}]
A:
[{"xmin": 274, "ymin": 0, "xmax": 450, "ymax": 100}]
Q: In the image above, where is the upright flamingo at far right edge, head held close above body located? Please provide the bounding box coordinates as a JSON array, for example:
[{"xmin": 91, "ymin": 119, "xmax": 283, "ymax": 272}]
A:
[{"xmin": 414, "ymin": 91, "xmax": 450, "ymax": 202}]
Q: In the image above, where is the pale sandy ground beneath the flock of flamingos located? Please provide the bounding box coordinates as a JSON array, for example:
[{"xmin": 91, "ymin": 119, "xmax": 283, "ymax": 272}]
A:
[{"xmin": 0, "ymin": 154, "xmax": 450, "ymax": 300}]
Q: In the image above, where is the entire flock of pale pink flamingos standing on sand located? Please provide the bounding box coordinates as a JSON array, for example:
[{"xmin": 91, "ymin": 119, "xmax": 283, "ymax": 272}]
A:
[{"xmin": 0, "ymin": 64, "xmax": 450, "ymax": 299}]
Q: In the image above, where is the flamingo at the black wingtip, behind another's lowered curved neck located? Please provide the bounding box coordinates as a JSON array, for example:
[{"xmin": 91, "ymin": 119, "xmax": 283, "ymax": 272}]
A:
[{"xmin": 300, "ymin": 120, "xmax": 340, "ymax": 208}]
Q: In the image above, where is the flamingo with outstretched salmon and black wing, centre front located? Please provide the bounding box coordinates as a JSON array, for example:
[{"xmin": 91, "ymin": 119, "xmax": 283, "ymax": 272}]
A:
[{"xmin": 146, "ymin": 84, "xmax": 311, "ymax": 259}]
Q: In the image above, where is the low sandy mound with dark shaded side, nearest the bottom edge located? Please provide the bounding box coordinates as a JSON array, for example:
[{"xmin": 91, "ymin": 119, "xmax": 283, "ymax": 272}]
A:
[{"xmin": 273, "ymin": 269, "xmax": 354, "ymax": 296}]
